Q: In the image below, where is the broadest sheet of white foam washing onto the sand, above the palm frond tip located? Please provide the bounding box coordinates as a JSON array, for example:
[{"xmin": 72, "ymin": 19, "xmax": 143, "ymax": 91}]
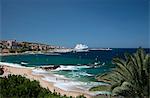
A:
[{"xmin": 42, "ymin": 75, "xmax": 107, "ymax": 91}]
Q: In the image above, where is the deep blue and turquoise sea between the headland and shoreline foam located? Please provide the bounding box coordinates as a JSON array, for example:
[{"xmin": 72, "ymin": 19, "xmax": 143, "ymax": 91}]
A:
[{"xmin": 0, "ymin": 49, "xmax": 149, "ymax": 81}]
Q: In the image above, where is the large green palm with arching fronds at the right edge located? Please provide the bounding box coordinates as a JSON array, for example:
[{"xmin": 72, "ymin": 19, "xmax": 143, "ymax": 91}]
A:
[{"xmin": 96, "ymin": 48, "xmax": 150, "ymax": 98}]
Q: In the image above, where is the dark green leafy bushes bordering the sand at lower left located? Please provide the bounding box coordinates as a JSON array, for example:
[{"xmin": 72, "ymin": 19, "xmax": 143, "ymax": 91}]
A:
[{"xmin": 0, "ymin": 75, "xmax": 85, "ymax": 98}]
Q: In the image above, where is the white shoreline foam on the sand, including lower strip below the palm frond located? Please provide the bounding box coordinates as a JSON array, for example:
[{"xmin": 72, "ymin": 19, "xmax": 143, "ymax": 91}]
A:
[{"xmin": 42, "ymin": 76, "xmax": 110, "ymax": 96}]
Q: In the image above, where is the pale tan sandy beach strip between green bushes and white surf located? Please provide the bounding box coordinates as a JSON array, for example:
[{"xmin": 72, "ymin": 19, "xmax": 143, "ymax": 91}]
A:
[{"xmin": 0, "ymin": 63, "xmax": 111, "ymax": 98}]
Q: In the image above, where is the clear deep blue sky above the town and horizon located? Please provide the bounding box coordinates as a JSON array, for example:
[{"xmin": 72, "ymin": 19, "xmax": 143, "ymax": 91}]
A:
[{"xmin": 0, "ymin": 0, "xmax": 150, "ymax": 48}]
